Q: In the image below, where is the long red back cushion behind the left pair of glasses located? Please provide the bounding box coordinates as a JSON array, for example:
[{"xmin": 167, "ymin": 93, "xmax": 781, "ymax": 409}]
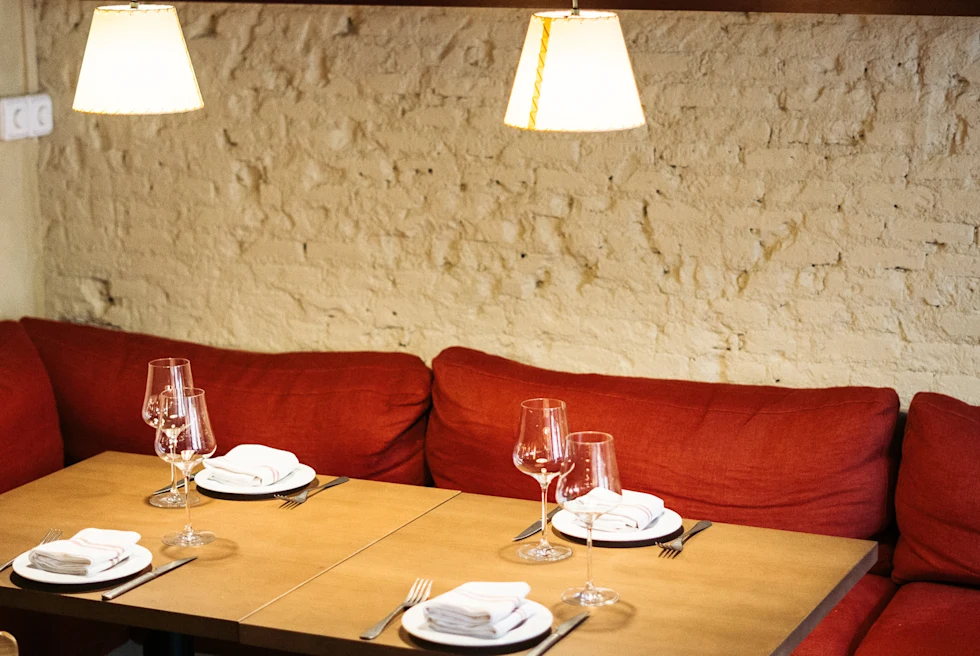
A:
[{"xmin": 22, "ymin": 319, "xmax": 431, "ymax": 484}]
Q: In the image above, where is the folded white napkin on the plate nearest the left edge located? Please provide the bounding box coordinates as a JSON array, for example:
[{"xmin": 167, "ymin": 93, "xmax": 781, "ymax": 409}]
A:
[{"xmin": 30, "ymin": 528, "xmax": 141, "ymax": 576}]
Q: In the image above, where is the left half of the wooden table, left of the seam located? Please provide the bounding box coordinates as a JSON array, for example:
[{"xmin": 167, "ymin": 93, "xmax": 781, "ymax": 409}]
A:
[{"xmin": 0, "ymin": 452, "xmax": 457, "ymax": 640}]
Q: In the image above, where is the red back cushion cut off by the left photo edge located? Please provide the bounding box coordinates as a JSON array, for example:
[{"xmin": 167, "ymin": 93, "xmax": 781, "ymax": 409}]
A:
[{"xmin": 0, "ymin": 321, "xmax": 64, "ymax": 492}]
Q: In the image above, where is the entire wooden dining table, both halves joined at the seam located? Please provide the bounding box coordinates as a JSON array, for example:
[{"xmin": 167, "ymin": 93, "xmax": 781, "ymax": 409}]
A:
[{"xmin": 0, "ymin": 453, "xmax": 877, "ymax": 656}]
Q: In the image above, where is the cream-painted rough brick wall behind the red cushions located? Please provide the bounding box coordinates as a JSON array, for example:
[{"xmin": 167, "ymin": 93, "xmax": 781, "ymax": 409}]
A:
[{"xmin": 30, "ymin": 0, "xmax": 980, "ymax": 404}]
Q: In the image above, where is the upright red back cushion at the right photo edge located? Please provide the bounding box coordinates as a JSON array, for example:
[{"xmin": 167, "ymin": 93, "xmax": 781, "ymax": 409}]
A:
[{"xmin": 892, "ymin": 393, "xmax": 980, "ymax": 588}]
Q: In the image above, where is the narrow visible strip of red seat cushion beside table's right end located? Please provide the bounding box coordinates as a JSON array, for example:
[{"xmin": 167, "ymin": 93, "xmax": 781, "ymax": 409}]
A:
[{"xmin": 793, "ymin": 574, "xmax": 898, "ymax": 656}]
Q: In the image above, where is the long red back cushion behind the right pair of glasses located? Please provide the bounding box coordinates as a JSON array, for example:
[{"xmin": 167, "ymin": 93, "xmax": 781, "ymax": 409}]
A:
[{"xmin": 426, "ymin": 348, "xmax": 898, "ymax": 538}]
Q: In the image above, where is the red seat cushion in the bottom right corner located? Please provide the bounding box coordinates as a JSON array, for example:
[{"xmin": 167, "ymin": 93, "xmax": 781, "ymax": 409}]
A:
[{"xmin": 857, "ymin": 583, "xmax": 980, "ymax": 656}]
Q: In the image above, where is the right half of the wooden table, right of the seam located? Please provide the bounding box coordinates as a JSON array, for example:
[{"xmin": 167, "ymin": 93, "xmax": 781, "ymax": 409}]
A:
[{"xmin": 240, "ymin": 494, "xmax": 877, "ymax": 656}]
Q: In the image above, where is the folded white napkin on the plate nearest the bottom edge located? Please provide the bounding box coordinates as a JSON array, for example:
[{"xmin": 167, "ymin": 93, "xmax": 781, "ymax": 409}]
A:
[{"xmin": 423, "ymin": 582, "xmax": 531, "ymax": 638}]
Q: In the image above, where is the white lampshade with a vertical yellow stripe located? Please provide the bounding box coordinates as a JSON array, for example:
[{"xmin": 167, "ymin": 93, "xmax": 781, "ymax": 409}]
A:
[{"xmin": 504, "ymin": 11, "xmax": 644, "ymax": 132}]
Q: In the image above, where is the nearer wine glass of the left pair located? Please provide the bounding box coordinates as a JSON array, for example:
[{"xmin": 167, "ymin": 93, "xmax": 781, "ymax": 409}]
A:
[{"xmin": 154, "ymin": 387, "xmax": 217, "ymax": 547}]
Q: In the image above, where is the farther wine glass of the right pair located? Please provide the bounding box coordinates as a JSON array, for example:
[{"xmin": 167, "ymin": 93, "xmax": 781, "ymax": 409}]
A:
[{"xmin": 514, "ymin": 399, "xmax": 572, "ymax": 562}]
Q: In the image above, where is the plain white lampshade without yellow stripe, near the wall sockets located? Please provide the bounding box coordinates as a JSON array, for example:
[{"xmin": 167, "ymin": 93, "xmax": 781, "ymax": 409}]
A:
[{"xmin": 72, "ymin": 5, "xmax": 204, "ymax": 114}]
